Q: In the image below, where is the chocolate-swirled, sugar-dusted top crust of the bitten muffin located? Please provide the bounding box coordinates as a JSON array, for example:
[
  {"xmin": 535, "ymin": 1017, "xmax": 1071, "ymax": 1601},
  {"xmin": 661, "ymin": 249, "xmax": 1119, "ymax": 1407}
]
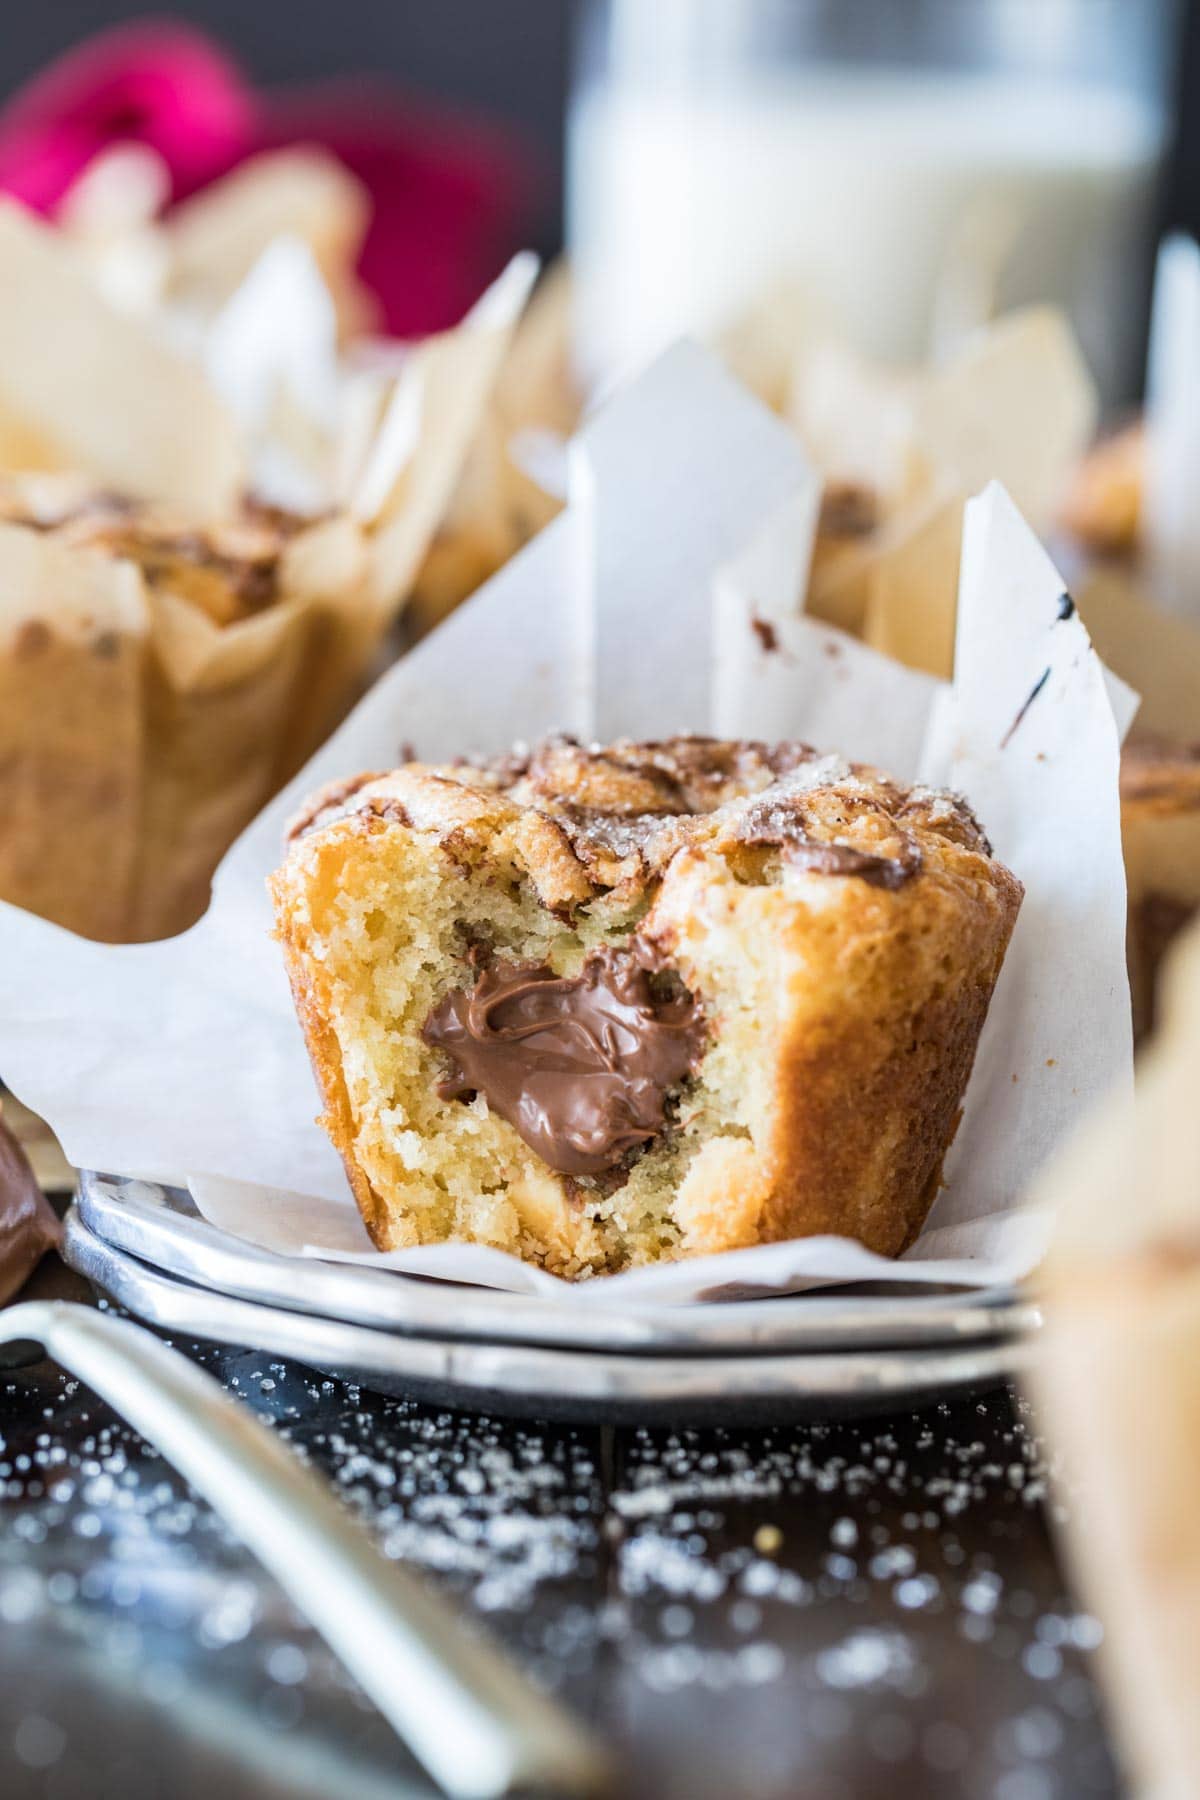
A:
[{"xmin": 291, "ymin": 736, "xmax": 991, "ymax": 911}]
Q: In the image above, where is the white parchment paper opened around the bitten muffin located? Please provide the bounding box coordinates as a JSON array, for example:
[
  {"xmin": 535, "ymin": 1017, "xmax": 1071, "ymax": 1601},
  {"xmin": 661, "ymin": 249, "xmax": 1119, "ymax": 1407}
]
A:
[{"xmin": 0, "ymin": 346, "xmax": 1133, "ymax": 1305}]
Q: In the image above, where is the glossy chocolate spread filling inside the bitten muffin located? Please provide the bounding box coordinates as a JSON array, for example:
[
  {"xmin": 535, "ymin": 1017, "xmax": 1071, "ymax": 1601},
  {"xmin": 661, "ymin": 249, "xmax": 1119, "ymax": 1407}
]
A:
[{"xmin": 421, "ymin": 938, "xmax": 705, "ymax": 1175}]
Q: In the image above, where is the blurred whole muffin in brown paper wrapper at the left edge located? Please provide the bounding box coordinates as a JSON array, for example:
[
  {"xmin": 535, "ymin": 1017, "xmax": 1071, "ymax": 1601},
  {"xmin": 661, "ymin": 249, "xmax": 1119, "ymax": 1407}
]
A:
[{"xmin": 0, "ymin": 472, "xmax": 370, "ymax": 943}]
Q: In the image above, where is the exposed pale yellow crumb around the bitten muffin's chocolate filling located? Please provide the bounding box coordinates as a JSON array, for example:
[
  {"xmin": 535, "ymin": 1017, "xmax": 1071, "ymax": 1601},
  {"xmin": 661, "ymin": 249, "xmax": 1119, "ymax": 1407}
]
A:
[{"xmin": 289, "ymin": 802, "xmax": 784, "ymax": 1273}]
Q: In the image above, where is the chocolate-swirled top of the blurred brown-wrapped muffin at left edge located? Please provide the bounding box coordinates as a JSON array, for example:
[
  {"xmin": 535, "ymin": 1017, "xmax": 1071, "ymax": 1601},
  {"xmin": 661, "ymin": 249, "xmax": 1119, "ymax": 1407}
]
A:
[{"xmin": 0, "ymin": 475, "xmax": 309, "ymax": 625}]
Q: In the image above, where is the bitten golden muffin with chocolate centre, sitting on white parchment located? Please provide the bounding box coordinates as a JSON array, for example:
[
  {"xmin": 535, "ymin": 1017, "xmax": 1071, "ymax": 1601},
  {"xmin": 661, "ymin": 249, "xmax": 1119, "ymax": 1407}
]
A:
[{"xmin": 272, "ymin": 738, "xmax": 1022, "ymax": 1276}]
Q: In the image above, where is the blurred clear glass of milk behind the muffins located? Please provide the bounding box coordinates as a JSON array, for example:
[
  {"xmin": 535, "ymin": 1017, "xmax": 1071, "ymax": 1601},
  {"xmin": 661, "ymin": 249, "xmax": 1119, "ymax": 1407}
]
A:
[{"xmin": 567, "ymin": 0, "xmax": 1178, "ymax": 405}]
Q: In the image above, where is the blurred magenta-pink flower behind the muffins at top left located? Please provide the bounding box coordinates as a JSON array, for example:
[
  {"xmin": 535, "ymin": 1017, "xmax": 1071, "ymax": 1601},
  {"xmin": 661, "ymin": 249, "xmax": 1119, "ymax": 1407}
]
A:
[{"xmin": 0, "ymin": 22, "xmax": 538, "ymax": 337}]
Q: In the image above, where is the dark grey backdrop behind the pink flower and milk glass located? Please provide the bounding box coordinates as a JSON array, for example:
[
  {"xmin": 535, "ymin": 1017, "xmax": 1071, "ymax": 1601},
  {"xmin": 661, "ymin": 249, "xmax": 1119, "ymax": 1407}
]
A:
[{"xmin": 0, "ymin": 0, "xmax": 1200, "ymax": 306}]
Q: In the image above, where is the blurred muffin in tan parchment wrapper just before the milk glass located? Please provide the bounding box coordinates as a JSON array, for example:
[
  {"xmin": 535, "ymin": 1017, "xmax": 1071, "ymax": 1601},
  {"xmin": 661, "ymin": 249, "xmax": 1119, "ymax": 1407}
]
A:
[{"xmin": 773, "ymin": 308, "xmax": 1096, "ymax": 679}]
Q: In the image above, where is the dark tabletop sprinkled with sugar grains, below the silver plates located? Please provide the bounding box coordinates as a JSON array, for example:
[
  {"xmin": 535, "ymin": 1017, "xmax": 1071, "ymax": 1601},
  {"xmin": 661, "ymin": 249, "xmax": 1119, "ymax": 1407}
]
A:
[{"xmin": 0, "ymin": 1271, "xmax": 1121, "ymax": 1800}]
